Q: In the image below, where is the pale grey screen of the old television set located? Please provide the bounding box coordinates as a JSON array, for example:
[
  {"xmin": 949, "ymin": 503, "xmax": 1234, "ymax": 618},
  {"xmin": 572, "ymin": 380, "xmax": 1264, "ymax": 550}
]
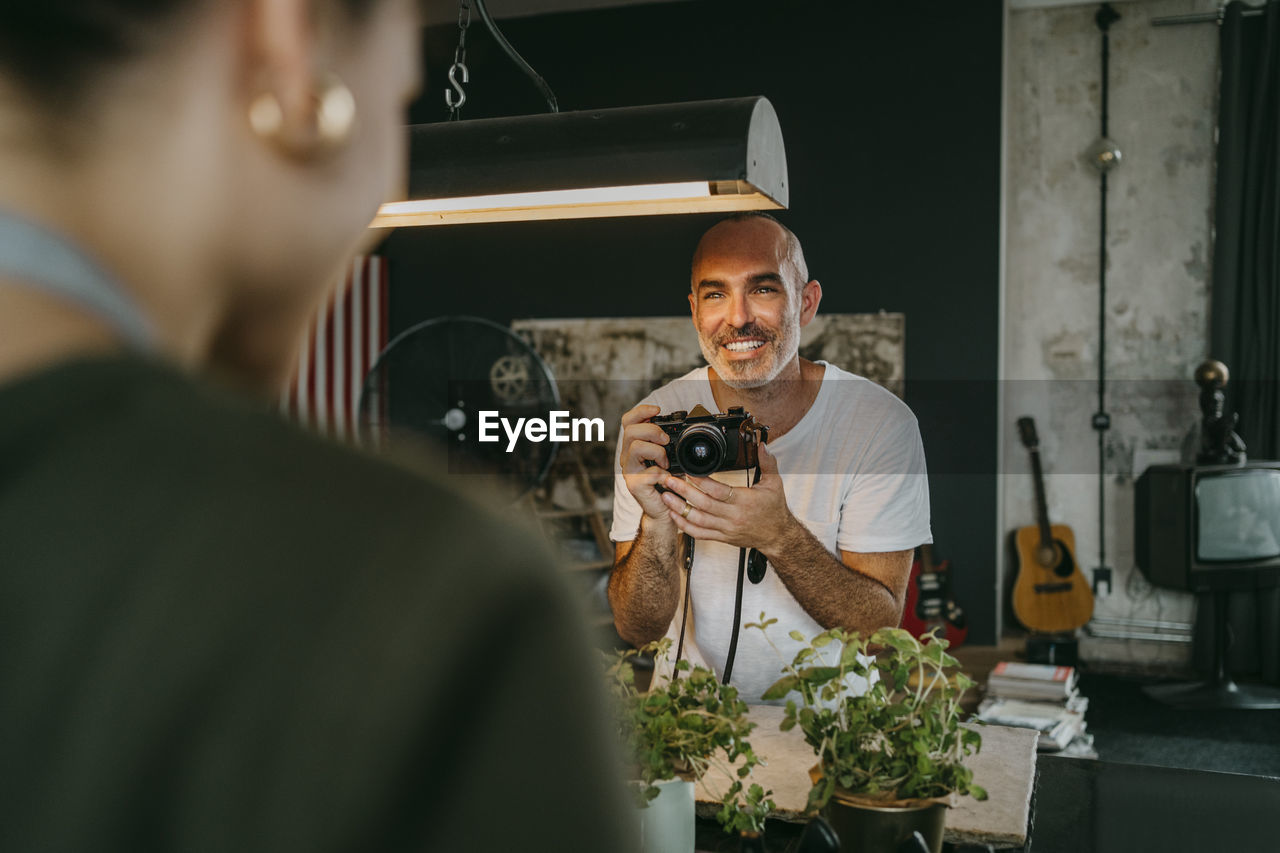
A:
[{"xmin": 1196, "ymin": 469, "xmax": 1280, "ymax": 562}]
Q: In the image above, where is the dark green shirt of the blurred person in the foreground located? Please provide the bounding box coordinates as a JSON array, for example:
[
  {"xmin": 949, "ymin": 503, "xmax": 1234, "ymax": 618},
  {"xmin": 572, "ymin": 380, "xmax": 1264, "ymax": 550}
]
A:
[{"xmin": 0, "ymin": 359, "xmax": 630, "ymax": 853}]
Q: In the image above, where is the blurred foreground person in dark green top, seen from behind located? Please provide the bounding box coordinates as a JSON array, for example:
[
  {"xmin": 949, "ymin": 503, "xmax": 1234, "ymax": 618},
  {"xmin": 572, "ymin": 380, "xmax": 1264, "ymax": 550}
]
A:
[{"xmin": 0, "ymin": 0, "xmax": 626, "ymax": 852}]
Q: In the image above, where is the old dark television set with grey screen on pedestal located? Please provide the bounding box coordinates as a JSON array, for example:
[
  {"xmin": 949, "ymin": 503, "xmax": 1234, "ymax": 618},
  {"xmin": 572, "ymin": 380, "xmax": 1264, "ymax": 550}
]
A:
[{"xmin": 1134, "ymin": 461, "xmax": 1280, "ymax": 592}]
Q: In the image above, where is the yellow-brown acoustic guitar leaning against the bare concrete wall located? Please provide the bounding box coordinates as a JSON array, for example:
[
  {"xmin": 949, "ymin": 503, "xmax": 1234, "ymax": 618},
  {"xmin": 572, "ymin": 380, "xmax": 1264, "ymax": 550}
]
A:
[{"xmin": 1014, "ymin": 418, "xmax": 1093, "ymax": 631}]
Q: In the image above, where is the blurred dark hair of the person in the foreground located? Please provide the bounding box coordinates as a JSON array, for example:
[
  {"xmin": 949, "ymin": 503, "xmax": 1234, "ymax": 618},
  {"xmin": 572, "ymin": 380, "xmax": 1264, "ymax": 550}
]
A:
[{"xmin": 0, "ymin": 0, "xmax": 378, "ymax": 110}]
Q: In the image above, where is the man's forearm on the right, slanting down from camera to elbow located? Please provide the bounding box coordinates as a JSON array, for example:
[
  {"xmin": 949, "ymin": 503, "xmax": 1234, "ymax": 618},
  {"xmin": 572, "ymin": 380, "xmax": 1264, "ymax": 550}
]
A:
[{"xmin": 764, "ymin": 521, "xmax": 902, "ymax": 633}]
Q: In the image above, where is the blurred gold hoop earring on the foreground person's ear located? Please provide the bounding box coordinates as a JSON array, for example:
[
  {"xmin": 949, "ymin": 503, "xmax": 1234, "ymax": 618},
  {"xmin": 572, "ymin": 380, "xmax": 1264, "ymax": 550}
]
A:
[{"xmin": 248, "ymin": 73, "xmax": 356, "ymax": 159}]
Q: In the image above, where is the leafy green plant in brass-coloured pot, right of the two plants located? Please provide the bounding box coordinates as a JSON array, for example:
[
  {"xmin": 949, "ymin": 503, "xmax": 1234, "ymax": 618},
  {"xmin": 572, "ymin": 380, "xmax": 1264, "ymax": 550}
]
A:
[{"xmin": 749, "ymin": 613, "xmax": 987, "ymax": 853}]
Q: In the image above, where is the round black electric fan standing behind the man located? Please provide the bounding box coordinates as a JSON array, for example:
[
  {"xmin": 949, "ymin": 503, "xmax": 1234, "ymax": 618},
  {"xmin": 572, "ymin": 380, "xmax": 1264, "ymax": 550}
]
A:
[{"xmin": 360, "ymin": 316, "xmax": 559, "ymax": 501}]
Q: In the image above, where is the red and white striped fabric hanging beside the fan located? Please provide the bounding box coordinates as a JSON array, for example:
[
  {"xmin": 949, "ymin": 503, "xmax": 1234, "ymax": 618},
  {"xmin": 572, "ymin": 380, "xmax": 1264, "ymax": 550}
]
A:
[{"xmin": 280, "ymin": 255, "xmax": 388, "ymax": 441}]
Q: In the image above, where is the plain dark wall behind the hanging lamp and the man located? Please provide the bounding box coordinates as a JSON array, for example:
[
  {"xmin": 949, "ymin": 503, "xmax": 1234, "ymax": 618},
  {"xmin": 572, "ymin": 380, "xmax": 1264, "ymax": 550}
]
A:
[{"xmin": 383, "ymin": 0, "xmax": 1002, "ymax": 643}]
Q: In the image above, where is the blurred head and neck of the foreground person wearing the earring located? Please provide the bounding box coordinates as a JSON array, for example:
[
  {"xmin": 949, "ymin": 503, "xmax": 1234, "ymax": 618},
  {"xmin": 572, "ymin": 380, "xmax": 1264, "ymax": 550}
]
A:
[{"xmin": 0, "ymin": 0, "xmax": 421, "ymax": 384}]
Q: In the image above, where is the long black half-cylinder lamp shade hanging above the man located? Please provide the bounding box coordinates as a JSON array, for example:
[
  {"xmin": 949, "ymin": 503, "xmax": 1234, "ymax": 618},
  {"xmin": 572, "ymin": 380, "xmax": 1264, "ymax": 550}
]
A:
[{"xmin": 372, "ymin": 97, "xmax": 788, "ymax": 228}]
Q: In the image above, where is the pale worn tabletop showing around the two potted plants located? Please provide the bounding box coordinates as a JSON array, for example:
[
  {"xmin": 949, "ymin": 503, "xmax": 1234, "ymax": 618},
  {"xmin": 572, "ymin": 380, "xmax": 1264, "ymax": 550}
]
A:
[{"xmin": 696, "ymin": 704, "xmax": 1038, "ymax": 847}]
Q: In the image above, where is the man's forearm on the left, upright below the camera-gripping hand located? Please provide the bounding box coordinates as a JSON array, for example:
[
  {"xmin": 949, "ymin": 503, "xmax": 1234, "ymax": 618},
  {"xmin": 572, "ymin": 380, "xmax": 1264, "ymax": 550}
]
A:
[{"xmin": 609, "ymin": 516, "xmax": 680, "ymax": 647}]
